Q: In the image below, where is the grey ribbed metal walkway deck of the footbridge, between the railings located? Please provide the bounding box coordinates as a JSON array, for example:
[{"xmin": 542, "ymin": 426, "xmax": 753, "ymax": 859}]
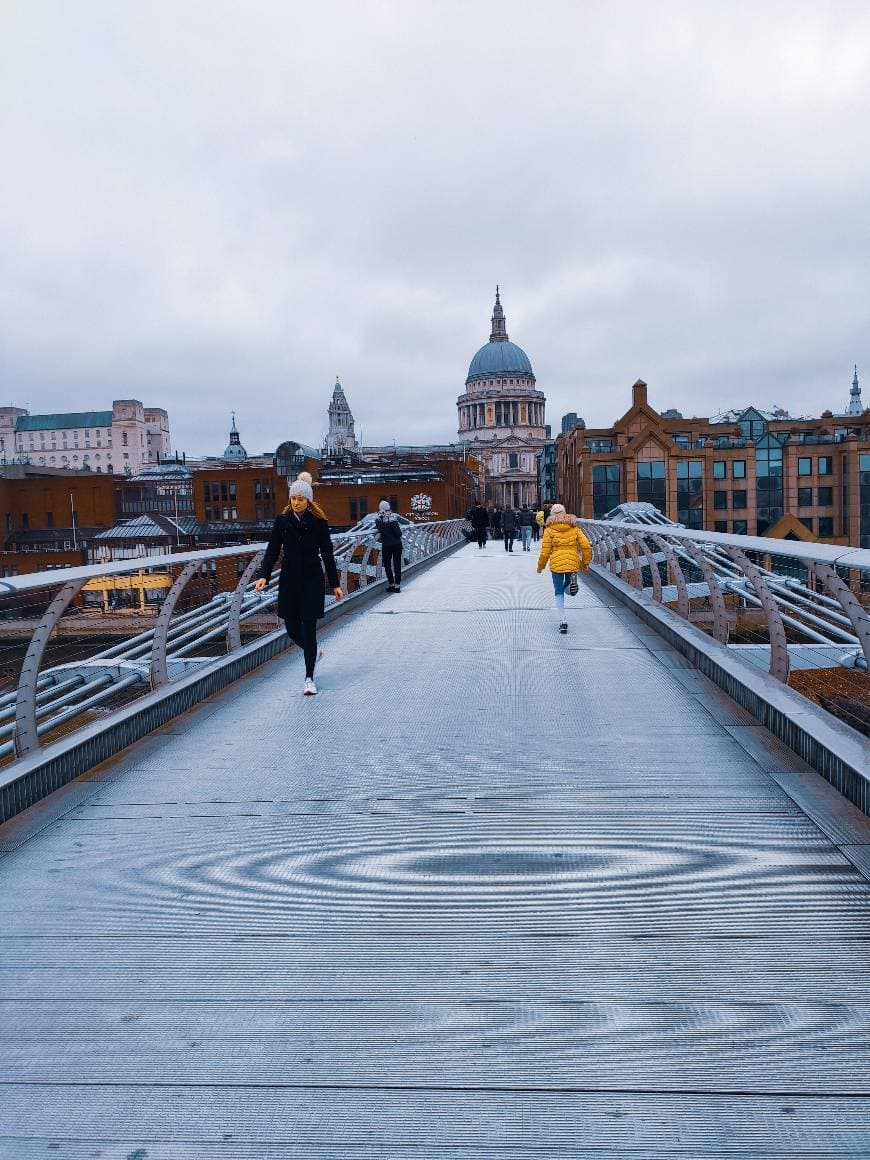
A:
[{"xmin": 0, "ymin": 544, "xmax": 870, "ymax": 1160}]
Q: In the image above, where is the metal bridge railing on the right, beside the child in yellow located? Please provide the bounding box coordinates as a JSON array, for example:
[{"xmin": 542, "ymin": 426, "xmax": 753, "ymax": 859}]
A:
[{"xmin": 580, "ymin": 515, "xmax": 870, "ymax": 733}]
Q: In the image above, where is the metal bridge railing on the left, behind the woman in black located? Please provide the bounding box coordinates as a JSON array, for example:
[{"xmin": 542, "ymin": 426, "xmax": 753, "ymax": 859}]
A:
[{"xmin": 0, "ymin": 520, "xmax": 463, "ymax": 764}]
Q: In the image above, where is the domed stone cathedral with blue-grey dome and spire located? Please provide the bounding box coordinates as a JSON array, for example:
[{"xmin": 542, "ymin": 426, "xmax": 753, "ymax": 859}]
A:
[{"xmin": 456, "ymin": 287, "xmax": 549, "ymax": 507}]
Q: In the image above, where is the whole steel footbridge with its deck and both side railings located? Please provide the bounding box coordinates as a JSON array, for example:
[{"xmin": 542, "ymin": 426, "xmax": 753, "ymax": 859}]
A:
[{"xmin": 0, "ymin": 519, "xmax": 870, "ymax": 1160}]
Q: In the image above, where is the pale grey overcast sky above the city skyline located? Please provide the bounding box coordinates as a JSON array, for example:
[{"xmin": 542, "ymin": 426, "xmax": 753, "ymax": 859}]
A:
[{"xmin": 0, "ymin": 0, "xmax": 870, "ymax": 454}]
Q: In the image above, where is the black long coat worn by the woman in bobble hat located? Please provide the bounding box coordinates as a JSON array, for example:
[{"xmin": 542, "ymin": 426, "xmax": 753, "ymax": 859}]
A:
[{"xmin": 260, "ymin": 508, "xmax": 339, "ymax": 621}]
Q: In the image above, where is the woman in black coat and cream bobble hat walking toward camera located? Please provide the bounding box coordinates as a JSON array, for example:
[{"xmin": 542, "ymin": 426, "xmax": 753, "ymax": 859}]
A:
[{"xmin": 254, "ymin": 471, "xmax": 345, "ymax": 697}]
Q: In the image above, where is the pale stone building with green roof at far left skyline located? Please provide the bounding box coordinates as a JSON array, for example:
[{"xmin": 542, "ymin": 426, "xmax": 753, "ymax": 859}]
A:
[{"xmin": 0, "ymin": 399, "xmax": 172, "ymax": 476}]
